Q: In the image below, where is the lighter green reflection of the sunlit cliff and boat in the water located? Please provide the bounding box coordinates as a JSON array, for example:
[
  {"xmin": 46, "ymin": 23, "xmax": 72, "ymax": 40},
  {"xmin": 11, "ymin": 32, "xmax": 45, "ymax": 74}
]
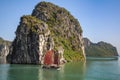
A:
[{"xmin": 39, "ymin": 62, "xmax": 86, "ymax": 80}]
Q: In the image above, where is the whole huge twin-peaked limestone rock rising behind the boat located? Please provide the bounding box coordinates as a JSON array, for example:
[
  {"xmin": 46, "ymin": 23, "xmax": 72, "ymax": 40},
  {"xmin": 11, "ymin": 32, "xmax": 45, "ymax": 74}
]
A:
[{"xmin": 7, "ymin": 2, "xmax": 85, "ymax": 64}]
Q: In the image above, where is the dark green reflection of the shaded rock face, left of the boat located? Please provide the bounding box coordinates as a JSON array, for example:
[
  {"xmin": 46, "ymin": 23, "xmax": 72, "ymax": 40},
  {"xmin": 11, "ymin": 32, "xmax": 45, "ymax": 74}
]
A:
[{"xmin": 7, "ymin": 64, "xmax": 39, "ymax": 80}]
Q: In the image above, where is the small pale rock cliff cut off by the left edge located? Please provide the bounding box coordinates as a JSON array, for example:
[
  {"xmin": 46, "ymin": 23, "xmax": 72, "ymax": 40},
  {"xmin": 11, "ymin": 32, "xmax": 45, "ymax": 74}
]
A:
[{"xmin": 0, "ymin": 38, "xmax": 11, "ymax": 63}]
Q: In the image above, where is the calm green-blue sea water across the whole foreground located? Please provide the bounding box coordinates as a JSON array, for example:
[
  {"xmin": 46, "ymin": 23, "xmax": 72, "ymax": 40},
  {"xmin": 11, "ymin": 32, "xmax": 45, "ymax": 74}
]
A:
[{"xmin": 0, "ymin": 59, "xmax": 120, "ymax": 80}]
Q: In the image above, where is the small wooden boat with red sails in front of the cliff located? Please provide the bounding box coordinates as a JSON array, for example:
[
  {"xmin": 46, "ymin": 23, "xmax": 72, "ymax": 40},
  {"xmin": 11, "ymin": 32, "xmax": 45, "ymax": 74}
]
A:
[{"xmin": 42, "ymin": 46, "xmax": 66, "ymax": 70}]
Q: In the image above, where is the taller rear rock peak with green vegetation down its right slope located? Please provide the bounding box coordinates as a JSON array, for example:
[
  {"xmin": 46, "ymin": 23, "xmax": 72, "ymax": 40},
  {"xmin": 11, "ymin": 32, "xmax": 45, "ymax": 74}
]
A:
[{"xmin": 32, "ymin": 2, "xmax": 85, "ymax": 61}]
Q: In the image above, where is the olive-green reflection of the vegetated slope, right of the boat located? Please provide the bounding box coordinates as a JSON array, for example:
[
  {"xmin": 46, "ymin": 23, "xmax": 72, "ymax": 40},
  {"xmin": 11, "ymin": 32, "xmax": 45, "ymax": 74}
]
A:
[{"xmin": 61, "ymin": 62, "xmax": 86, "ymax": 80}]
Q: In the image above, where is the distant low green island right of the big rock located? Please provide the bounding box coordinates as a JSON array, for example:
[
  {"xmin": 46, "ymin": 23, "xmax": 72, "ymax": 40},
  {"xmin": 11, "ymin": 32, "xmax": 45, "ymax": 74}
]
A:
[{"xmin": 84, "ymin": 38, "xmax": 118, "ymax": 57}]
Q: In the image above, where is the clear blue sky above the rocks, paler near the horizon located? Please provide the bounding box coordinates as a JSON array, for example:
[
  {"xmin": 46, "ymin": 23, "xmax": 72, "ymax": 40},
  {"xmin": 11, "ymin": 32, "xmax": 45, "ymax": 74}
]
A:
[{"xmin": 0, "ymin": 0, "xmax": 120, "ymax": 53}]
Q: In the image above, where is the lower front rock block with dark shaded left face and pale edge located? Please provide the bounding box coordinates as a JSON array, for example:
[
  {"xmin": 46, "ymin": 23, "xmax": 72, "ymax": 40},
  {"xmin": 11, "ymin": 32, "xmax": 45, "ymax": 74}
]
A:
[{"xmin": 8, "ymin": 16, "xmax": 54, "ymax": 64}]
